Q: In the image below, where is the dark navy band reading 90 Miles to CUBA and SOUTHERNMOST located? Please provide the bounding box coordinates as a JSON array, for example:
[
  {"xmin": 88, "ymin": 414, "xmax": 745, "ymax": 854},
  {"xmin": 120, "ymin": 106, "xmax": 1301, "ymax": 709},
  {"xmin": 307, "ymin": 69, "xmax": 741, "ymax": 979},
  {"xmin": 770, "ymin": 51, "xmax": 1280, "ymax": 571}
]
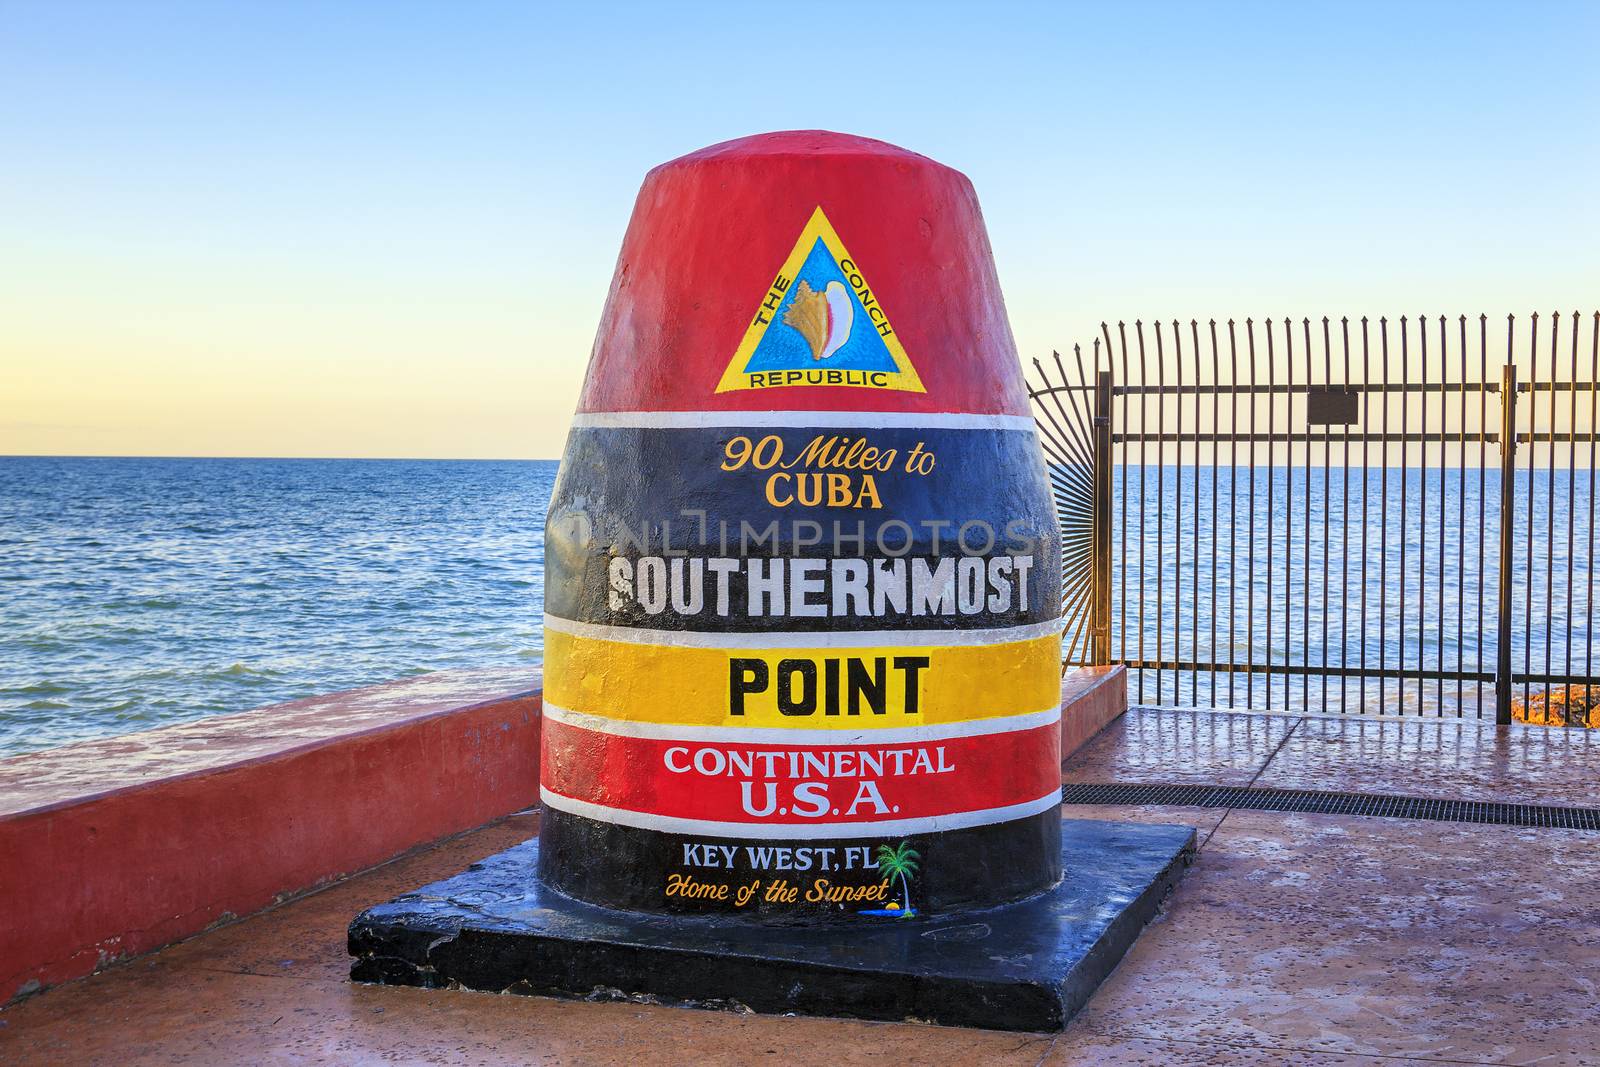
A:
[{"xmin": 546, "ymin": 427, "xmax": 1061, "ymax": 632}]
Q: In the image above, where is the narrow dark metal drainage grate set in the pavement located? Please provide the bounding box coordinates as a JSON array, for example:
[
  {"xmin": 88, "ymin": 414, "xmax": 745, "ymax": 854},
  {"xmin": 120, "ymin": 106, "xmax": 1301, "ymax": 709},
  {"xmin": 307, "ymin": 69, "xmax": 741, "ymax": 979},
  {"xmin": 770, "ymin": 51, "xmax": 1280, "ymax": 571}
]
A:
[{"xmin": 1061, "ymin": 782, "xmax": 1600, "ymax": 830}]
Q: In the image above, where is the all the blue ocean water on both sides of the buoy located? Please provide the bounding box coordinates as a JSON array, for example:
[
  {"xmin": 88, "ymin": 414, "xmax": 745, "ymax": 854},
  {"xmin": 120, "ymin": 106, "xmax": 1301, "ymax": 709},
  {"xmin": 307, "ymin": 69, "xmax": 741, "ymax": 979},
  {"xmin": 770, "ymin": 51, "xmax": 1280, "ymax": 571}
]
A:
[{"xmin": 0, "ymin": 458, "xmax": 1597, "ymax": 755}]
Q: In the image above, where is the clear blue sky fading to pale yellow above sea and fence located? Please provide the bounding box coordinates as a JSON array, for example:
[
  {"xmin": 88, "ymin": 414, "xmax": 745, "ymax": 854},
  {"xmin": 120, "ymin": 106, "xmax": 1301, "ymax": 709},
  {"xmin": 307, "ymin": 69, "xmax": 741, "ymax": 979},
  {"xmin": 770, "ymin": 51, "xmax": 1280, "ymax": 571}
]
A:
[{"xmin": 0, "ymin": 0, "xmax": 1600, "ymax": 456}]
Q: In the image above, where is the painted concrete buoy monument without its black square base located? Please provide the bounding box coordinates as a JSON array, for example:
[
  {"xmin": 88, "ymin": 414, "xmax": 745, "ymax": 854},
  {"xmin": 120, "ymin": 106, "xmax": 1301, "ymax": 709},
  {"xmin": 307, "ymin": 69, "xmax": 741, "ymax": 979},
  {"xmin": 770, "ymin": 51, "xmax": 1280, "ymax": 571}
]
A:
[{"xmin": 541, "ymin": 133, "xmax": 1061, "ymax": 921}]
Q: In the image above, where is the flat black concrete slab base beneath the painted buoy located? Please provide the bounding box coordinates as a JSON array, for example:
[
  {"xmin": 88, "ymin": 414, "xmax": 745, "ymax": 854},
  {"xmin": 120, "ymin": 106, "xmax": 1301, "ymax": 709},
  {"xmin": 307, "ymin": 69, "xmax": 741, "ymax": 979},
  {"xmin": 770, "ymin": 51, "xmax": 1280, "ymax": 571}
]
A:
[{"xmin": 350, "ymin": 819, "xmax": 1195, "ymax": 1030}]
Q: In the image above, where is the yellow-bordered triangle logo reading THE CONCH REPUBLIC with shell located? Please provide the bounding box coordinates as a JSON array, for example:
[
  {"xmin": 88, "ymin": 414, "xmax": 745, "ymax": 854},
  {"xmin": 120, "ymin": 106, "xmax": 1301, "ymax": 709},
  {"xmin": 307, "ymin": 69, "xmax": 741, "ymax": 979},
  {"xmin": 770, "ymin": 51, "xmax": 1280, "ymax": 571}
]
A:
[{"xmin": 717, "ymin": 208, "xmax": 926, "ymax": 392}]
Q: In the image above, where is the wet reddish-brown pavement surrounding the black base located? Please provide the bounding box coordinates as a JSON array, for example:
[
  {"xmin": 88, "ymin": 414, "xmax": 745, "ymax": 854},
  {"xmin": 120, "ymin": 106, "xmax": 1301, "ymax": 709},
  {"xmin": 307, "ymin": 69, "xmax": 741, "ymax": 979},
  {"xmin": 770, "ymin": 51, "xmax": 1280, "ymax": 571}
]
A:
[{"xmin": 0, "ymin": 709, "xmax": 1600, "ymax": 1067}]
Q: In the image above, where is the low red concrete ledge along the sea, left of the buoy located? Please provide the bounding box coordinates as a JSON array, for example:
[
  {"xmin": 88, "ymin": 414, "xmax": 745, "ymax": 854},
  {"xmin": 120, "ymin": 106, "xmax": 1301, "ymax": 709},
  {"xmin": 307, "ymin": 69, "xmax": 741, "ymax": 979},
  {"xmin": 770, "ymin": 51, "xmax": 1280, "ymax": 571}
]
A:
[{"xmin": 0, "ymin": 670, "xmax": 539, "ymax": 1003}]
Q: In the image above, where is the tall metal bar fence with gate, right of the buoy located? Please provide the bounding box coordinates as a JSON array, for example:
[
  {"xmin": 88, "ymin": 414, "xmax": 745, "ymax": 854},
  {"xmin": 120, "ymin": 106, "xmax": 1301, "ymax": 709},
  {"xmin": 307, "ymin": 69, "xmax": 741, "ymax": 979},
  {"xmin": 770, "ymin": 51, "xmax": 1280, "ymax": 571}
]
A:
[{"xmin": 1030, "ymin": 312, "xmax": 1600, "ymax": 721}]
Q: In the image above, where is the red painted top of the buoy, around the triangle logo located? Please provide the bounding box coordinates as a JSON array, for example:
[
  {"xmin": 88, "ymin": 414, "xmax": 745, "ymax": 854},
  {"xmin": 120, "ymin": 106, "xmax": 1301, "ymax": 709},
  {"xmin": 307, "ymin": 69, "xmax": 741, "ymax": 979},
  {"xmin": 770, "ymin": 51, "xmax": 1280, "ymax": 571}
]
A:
[{"xmin": 579, "ymin": 130, "xmax": 1027, "ymax": 414}]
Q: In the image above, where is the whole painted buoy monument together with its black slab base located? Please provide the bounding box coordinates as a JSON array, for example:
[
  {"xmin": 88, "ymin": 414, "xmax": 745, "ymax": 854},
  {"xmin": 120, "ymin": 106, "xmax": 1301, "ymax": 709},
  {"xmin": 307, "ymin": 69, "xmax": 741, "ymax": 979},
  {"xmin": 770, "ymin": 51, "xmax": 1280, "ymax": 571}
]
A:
[{"xmin": 350, "ymin": 131, "xmax": 1190, "ymax": 1029}]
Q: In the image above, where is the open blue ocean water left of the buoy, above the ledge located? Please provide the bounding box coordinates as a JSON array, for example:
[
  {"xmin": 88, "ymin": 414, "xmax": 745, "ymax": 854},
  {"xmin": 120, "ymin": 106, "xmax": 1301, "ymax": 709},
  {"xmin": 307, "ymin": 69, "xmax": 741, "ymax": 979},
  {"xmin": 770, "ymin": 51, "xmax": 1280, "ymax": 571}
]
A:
[{"xmin": 0, "ymin": 458, "xmax": 557, "ymax": 755}]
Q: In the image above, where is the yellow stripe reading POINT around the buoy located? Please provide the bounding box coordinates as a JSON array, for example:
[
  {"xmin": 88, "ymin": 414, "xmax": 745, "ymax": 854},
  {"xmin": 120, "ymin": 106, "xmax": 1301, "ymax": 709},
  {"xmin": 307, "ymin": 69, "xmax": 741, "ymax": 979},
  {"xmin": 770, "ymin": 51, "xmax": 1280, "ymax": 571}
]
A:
[{"xmin": 544, "ymin": 630, "xmax": 1061, "ymax": 729}]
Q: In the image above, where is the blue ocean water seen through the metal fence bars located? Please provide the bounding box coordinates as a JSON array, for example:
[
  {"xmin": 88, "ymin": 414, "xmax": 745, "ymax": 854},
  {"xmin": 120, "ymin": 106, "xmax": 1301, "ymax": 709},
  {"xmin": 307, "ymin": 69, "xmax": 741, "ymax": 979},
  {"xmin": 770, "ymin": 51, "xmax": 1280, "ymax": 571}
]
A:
[{"xmin": 1107, "ymin": 463, "xmax": 1600, "ymax": 718}]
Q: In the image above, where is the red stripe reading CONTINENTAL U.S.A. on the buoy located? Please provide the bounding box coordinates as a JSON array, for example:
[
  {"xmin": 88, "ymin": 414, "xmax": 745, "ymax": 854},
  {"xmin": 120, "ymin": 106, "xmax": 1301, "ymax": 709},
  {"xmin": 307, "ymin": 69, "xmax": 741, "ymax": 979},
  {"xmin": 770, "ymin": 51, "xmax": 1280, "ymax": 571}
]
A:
[{"xmin": 542, "ymin": 720, "xmax": 1061, "ymax": 827}]
